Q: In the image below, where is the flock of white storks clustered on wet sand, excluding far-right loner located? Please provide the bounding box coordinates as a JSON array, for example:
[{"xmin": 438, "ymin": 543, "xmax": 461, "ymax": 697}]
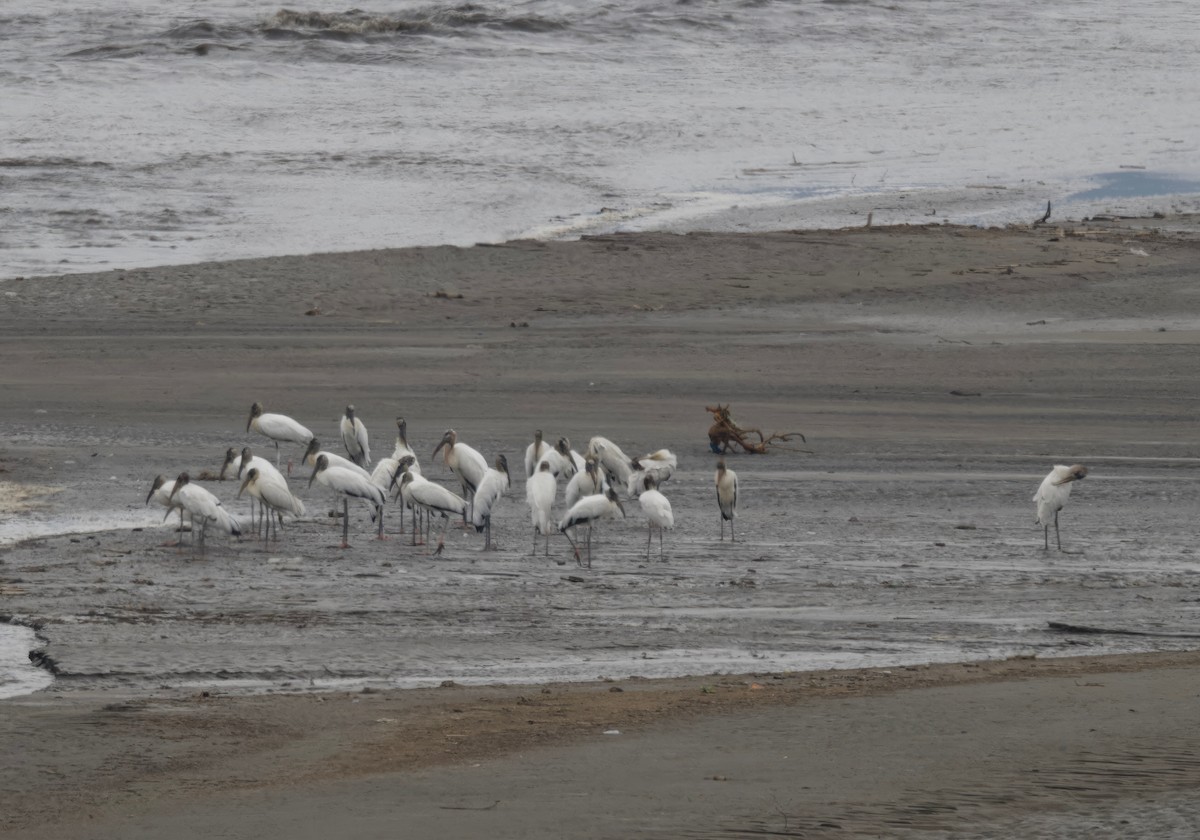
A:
[{"xmin": 146, "ymin": 402, "xmax": 738, "ymax": 566}]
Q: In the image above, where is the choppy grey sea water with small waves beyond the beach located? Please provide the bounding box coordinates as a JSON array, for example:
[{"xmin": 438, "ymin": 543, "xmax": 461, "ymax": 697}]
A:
[{"xmin": 7, "ymin": 0, "xmax": 1200, "ymax": 280}]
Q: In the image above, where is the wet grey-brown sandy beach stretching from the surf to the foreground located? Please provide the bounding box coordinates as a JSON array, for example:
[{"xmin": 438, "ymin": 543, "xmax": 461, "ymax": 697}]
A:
[{"xmin": 0, "ymin": 217, "xmax": 1200, "ymax": 838}]
